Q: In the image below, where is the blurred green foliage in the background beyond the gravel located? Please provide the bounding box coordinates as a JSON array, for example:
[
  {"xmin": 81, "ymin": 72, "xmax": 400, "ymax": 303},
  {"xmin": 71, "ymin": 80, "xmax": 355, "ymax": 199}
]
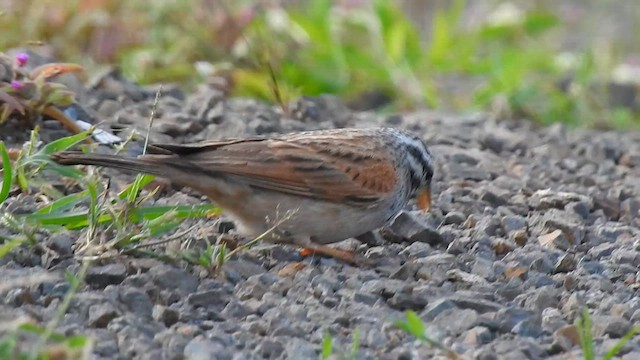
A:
[{"xmin": 0, "ymin": 0, "xmax": 640, "ymax": 127}]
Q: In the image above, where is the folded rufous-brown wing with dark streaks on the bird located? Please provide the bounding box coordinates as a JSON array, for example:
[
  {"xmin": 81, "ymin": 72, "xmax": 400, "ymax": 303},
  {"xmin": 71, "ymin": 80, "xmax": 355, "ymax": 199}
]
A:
[{"xmin": 150, "ymin": 132, "xmax": 396, "ymax": 206}]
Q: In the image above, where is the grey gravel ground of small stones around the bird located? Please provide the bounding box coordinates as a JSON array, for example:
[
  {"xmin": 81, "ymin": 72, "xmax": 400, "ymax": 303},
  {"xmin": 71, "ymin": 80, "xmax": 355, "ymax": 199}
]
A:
[{"xmin": 0, "ymin": 68, "xmax": 640, "ymax": 360}]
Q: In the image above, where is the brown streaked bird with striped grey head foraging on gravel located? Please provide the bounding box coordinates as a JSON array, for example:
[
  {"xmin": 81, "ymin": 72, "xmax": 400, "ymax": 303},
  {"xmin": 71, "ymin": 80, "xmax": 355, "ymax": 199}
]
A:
[{"xmin": 51, "ymin": 127, "xmax": 434, "ymax": 264}]
